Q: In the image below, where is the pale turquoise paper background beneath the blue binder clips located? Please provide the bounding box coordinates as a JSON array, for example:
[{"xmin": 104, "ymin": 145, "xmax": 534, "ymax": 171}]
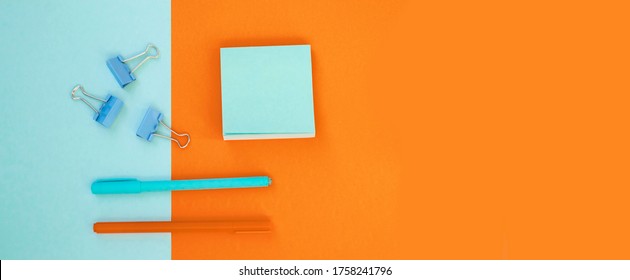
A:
[{"xmin": 0, "ymin": 0, "xmax": 171, "ymax": 259}]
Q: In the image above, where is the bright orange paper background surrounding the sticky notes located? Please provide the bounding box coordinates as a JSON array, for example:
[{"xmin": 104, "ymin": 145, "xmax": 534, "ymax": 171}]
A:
[{"xmin": 172, "ymin": 0, "xmax": 630, "ymax": 259}]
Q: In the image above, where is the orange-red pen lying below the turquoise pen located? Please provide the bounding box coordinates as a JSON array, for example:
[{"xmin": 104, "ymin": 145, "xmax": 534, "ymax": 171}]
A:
[{"xmin": 94, "ymin": 220, "xmax": 271, "ymax": 233}]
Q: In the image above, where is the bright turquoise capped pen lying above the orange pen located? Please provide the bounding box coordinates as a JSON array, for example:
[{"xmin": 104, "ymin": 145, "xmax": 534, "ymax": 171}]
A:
[{"xmin": 92, "ymin": 176, "xmax": 271, "ymax": 194}]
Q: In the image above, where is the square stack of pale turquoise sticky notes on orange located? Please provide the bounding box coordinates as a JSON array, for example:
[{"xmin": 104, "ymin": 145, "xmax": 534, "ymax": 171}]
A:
[{"xmin": 221, "ymin": 45, "xmax": 315, "ymax": 140}]
